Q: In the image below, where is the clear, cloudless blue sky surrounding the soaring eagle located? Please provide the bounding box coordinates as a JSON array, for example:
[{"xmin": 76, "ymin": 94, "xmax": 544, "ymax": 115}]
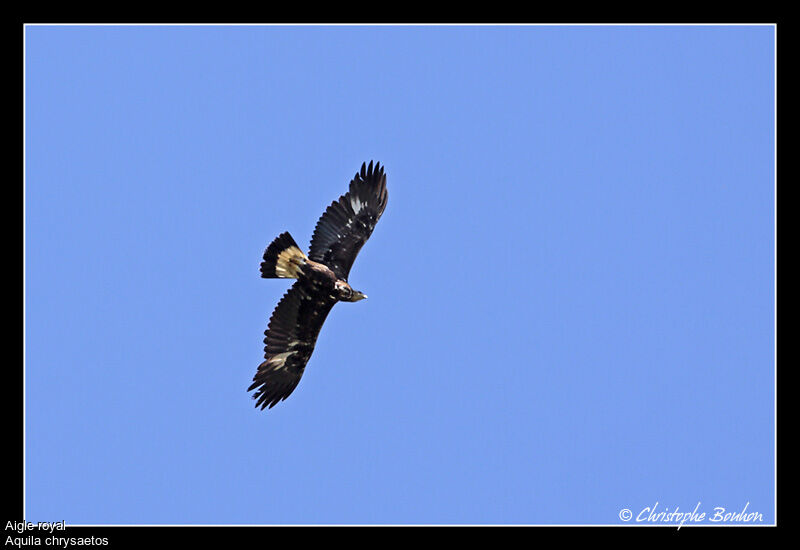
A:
[{"xmin": 25, "ymin": 26, "xmax": 775, "ymax": 524}]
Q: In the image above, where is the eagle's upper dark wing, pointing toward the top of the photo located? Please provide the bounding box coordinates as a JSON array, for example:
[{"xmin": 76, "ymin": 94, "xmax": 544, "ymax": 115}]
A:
[{"xmin": 308, "ymin": 161, "xmax": 388, "ymax": 280}]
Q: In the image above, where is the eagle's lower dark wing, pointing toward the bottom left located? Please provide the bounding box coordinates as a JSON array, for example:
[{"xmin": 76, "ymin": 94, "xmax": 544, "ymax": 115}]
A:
[{"xmin": 247, "ymin": 281, "xmax": 336, "ymax": 410}]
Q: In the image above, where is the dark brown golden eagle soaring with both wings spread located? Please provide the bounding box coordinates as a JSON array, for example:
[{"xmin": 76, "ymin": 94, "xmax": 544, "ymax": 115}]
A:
[{"xmin": 247, "ymin": 161, "xmax": 388, "ymax": 410}]
